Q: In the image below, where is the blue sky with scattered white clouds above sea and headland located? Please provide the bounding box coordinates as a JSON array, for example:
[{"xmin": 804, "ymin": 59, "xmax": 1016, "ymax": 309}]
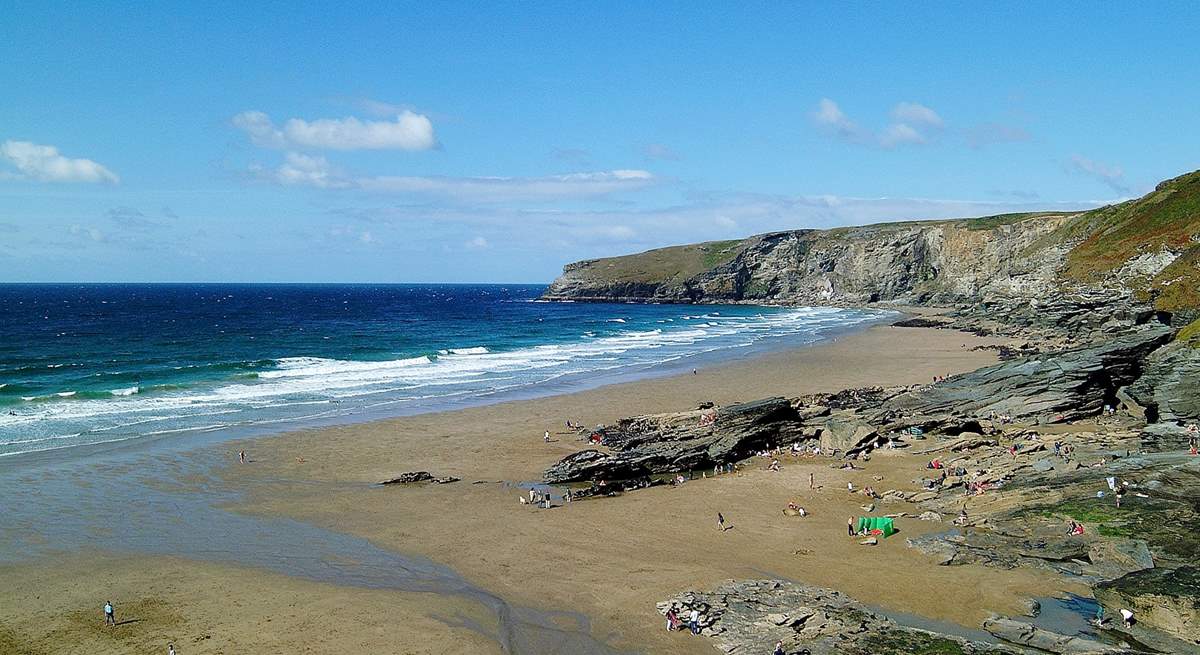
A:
[{"xmin": 0, "ymin": 2, "xmax": 1200, "ymax": 282}]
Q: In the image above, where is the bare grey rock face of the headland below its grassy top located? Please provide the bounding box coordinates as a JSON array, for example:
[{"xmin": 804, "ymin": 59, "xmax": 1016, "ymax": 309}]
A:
[{"xmin": 545, "ymin": 215, "xmax": 1072, "ymax": 304}]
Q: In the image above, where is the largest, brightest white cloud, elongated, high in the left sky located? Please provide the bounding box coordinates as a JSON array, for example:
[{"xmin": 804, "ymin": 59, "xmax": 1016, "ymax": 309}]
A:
[{"xmin": 233, "ymin": 109, "xmax": 438, "ymax": 150}]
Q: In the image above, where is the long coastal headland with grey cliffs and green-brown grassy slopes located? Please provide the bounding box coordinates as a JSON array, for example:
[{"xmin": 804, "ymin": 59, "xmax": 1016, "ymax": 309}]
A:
[{"xmin": 544, "ymin": 172, "xmax": 1200, "ymax": 314}]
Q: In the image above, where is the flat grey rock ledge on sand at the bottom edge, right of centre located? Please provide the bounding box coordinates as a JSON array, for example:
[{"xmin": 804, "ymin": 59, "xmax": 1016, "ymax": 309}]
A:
[{"xmin": 658, "ymin": 579, "xmax": 1019, "ymax": 655}]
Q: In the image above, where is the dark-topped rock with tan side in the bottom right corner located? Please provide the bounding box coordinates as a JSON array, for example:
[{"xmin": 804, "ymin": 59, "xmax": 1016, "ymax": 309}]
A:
[{"xmin": 1096, "ymin": 566, "xmax": 1200, "ymax": 644}]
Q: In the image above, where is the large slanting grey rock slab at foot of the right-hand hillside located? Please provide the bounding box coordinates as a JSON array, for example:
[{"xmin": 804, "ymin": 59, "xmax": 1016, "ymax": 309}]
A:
[{"xmin": 883, "ymin": 325, "xmax": 1172, "ymax": 421}]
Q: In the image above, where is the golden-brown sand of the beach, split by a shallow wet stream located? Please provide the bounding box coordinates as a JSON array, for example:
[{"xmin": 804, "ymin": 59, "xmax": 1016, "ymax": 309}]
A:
[{"xmin": 0, "ymin": 326, "xmax": 1089, "ymax": 654}]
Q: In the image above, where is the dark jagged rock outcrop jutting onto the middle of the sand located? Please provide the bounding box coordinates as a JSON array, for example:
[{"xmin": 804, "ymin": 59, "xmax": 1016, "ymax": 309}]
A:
[{"xmin": 544, "ymin": 398, "xmax": 804, "ymax": 483}]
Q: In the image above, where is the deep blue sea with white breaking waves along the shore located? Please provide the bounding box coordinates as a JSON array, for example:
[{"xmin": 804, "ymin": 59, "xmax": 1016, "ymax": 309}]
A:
[{"xmin": 0, "ymin": 284, "xmax": 881, "ymax": 457}]
